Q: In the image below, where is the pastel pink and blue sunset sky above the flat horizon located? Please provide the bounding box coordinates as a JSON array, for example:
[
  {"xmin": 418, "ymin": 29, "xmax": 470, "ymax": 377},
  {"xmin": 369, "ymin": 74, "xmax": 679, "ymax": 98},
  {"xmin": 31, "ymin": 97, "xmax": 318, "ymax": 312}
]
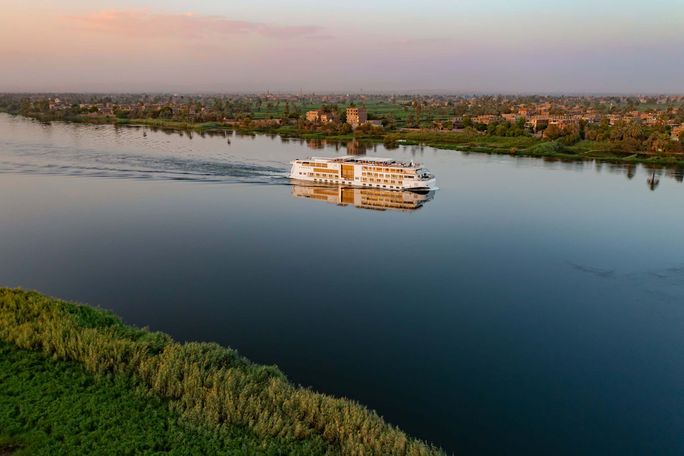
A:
[{"xmin": 0, "ymin": 0, "xmax": 684, "ymax": 94}]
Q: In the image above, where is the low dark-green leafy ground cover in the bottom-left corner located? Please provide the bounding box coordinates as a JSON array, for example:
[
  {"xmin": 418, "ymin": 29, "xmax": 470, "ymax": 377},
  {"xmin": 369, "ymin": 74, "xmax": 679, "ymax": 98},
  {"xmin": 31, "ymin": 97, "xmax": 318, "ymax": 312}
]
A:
[{"xmin": 0, "ymin": 343, "xmax": 322, "ymax": 456}]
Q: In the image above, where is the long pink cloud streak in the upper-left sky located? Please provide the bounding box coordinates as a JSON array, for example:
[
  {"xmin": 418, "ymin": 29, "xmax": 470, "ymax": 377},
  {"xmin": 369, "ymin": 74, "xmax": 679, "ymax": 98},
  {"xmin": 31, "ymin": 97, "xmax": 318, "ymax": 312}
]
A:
[{"xmin": 64, "ymin": 10, "xmax": 322, "ymax": 39}]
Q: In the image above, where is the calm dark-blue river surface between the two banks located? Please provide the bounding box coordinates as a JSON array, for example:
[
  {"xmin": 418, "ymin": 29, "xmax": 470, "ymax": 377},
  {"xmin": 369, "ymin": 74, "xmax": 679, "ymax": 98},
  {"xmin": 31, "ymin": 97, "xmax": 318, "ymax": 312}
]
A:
[{"xmin": 0, "ymin": 115, "xmax": 684, "ymax": 455}]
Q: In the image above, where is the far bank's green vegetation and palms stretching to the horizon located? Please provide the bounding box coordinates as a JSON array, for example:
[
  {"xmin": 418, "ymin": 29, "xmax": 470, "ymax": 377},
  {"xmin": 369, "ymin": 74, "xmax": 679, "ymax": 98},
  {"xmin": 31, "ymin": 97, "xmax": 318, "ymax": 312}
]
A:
[{"xmin": 0, "ymin": 94, "xmax": 684, "ymax": 166}]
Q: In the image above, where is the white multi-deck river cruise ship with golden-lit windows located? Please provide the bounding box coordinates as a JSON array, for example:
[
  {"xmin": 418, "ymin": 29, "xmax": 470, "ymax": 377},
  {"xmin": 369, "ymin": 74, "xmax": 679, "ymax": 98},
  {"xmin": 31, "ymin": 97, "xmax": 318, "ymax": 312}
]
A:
[{"xmin": 290, "ymin": 155, "xmax": 437, "ymax": 192}]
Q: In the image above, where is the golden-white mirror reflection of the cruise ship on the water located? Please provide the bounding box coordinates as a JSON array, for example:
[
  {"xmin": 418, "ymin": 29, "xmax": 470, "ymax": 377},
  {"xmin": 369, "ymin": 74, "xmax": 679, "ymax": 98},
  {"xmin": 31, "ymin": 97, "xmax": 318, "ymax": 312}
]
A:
[{"xmin": 292, "ymin": 184, "xmax": 434, "ymax": 212}]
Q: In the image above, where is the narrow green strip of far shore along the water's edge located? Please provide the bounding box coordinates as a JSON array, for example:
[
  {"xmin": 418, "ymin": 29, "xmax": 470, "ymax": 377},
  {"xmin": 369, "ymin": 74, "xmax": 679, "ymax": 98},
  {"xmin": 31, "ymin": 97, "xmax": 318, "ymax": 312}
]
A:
[{"xmin": 9, "ymin": 113, "xmax": 684, "ymax": 167}]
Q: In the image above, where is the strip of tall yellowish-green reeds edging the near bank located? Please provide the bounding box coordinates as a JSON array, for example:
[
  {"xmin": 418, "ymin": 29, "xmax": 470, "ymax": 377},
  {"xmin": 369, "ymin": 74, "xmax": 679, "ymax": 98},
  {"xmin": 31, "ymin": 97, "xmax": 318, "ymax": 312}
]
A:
[{"xmin": 0, "ymin": 289, "xmax": 441, "ymax": 455}]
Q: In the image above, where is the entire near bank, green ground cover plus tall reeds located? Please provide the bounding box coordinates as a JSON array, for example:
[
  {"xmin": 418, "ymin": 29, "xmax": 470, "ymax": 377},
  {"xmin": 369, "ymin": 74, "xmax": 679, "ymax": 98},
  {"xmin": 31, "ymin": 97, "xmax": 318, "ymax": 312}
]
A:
[{"xmin": 0, "ymin": 289, "xmax": 443, "ymax": 455}]
